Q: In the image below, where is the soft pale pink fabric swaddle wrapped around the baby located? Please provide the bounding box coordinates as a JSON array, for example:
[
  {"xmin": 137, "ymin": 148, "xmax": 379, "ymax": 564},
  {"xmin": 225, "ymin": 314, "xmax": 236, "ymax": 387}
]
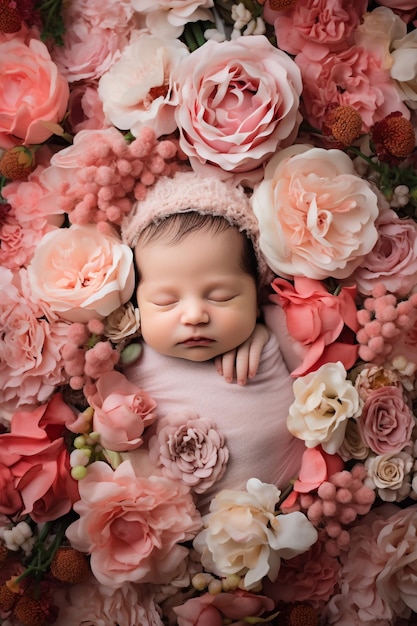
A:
[{"xmin": 126, "ymin": 324, "xmax": 304, "ymax": 512}]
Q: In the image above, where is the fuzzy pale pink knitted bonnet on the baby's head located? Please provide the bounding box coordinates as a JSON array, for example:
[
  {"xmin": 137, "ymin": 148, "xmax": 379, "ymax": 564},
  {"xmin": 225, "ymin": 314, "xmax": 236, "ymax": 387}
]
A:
[{"xmin": 122, "ymin": 171, "xmax": 271, "ymax": 284}]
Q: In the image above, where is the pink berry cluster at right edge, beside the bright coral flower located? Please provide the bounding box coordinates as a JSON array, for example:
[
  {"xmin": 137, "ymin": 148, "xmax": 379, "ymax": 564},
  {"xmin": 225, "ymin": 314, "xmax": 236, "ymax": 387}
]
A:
[{"xmin": 356, "ymin": 283, "xmax": 417, "ymax": 364}]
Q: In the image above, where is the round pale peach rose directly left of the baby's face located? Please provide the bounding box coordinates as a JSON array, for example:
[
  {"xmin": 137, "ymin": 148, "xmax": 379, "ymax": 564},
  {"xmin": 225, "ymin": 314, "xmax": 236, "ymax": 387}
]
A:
[{"xmin": 28, "ymin": 224, "xmax": 135, "ymax": 323}]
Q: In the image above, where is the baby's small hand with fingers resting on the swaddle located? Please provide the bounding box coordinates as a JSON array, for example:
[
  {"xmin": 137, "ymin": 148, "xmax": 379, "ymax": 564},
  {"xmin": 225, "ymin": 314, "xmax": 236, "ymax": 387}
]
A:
[{"xmin": 214, "ymin": 324, "xmax": 269, "ymax": 385}]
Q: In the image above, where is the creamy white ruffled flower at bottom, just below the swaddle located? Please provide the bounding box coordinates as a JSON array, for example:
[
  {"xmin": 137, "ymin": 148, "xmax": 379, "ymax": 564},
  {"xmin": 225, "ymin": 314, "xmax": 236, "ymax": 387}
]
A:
[{"xmin": 193, "ymin": 478, "xmax": 317, "ymax": 590}]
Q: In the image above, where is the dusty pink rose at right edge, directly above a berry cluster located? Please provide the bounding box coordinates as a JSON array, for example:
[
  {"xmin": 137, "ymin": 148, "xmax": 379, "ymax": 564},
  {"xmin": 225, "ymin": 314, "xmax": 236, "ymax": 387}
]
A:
[{"xmin": 350, "ymin": 210, "xmax": 417, "ymax": 297}]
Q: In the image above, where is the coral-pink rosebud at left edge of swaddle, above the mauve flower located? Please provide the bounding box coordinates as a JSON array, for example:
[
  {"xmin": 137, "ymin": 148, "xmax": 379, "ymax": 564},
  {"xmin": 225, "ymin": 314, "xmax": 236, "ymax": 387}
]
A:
[{"xmin": 87, "ymin": 371, "xmax": 156, "ymax": 452}]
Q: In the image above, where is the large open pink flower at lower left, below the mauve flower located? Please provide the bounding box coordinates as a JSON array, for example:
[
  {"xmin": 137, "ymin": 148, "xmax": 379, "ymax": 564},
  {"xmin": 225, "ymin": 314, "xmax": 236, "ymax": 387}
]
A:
[{"xmin": 67, "ymin": 461, "xmax": 201, "ymax": 588}]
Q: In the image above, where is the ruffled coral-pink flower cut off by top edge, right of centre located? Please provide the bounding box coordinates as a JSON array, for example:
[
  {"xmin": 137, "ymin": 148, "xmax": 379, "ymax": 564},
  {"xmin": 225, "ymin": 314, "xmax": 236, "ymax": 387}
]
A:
[{"xmin": 263, "ymin": 0, "xmax": 368, "ymax": 59}]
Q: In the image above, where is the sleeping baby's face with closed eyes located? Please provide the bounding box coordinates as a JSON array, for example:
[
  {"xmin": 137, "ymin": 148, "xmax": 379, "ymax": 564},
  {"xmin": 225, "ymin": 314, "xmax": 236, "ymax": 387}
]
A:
[{"xmin": 135, "ymin": 224, "xmax": 258, "ymax": 361}]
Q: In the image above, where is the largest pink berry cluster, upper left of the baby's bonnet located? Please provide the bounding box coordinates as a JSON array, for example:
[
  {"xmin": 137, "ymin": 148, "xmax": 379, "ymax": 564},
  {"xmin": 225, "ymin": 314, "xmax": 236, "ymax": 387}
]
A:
[{"xmin": 59, "ymin": 127, "xmax": 182, "ymax": 232}]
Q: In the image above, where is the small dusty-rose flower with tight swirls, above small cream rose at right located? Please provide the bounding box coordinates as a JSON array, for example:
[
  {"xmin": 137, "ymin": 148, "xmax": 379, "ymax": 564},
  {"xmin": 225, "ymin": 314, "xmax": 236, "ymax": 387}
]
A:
[{"xmin": 359, "ymin": 386, "xmax": 414, "ymax": 454}]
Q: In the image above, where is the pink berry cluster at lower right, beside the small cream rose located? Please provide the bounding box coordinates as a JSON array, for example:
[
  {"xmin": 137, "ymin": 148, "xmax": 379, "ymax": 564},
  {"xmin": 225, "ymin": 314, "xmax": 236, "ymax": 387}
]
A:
[{"xmin": 284, "ymin": 463, "xmax": 375, "ymax": 556}]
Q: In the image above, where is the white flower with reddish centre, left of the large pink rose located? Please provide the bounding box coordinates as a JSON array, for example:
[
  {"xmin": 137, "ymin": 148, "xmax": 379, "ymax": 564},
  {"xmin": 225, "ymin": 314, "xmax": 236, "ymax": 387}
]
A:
[{"xmin": 98, "ymin": 33, "xmax": 190, "ymax": 137}]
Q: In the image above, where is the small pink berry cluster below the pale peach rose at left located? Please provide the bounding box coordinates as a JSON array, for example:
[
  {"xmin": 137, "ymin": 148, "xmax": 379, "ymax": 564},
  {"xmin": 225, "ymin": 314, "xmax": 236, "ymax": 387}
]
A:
[{"xmin": 62, "ymin": 319, "xmax": 120, "ymax": 396}]
